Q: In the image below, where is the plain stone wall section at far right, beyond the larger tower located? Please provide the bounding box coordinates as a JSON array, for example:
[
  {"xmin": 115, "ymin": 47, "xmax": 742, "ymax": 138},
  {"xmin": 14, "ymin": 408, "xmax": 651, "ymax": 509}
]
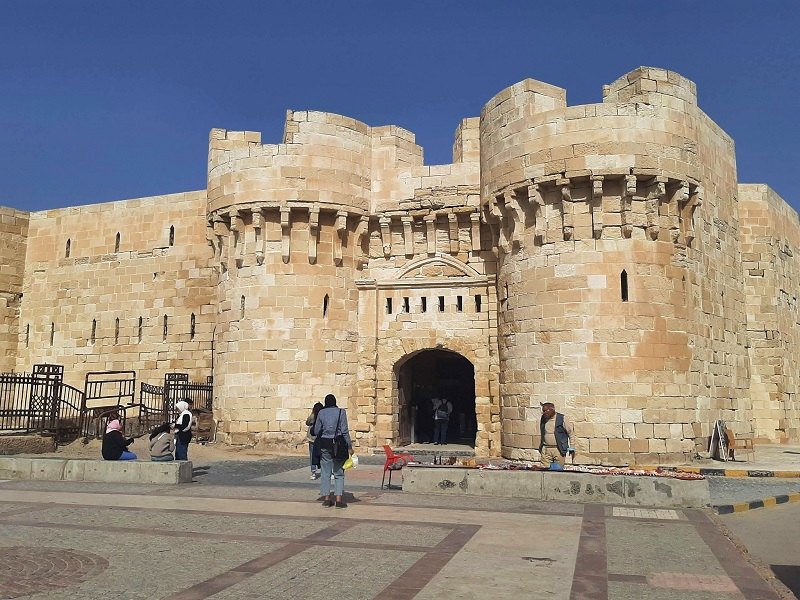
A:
[{"xmin": 739, "ymin": 184, "xmax": 800, "ymax": 442}]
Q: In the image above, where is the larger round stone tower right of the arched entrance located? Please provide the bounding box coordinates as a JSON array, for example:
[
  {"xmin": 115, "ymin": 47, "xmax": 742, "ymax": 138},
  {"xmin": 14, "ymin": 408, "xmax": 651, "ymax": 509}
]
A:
[{"xmin": 480, "ymin": 67, "xmax": 750, "ymax": 464}]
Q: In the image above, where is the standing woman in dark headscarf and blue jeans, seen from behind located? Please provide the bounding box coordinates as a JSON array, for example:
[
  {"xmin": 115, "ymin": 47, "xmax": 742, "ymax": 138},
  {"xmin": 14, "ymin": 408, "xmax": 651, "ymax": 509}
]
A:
[{"xmin": 312, "ymin": 394, "xmax": 353, "ymax": 508}]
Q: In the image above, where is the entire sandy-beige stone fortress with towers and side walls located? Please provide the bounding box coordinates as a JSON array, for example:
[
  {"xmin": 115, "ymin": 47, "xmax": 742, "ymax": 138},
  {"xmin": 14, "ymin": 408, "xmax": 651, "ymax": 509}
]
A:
[{"xmin": 0, "ymin": 67, "xmax": 800, "ymax": 464}]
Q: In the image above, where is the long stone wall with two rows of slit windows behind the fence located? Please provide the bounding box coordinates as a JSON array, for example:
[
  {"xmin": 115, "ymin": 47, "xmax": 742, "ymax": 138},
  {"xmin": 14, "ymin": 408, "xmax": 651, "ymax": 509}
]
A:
[{"xmin": 16, "ymin": 192, "xmax": 215, "ymax": 389}]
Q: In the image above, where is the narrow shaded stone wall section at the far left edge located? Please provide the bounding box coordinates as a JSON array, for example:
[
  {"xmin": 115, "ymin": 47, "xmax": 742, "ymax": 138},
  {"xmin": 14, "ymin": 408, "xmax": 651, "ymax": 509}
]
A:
[{"xmin": 0, "ymin": 207, "xmax": 30, "ymax": 373}]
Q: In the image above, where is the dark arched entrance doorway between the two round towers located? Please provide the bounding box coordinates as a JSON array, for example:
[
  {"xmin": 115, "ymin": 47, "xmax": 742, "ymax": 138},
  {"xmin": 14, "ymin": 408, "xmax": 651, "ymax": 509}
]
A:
[{"xmin": 396, "ymin": 350, "xmax": 478, "ymax": 446}]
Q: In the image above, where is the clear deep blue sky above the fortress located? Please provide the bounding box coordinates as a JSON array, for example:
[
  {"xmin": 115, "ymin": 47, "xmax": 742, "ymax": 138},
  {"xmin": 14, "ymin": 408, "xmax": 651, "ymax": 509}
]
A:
[{"xmin": 0, "ymin": 0, "xmax": 800, "ymax": 210}]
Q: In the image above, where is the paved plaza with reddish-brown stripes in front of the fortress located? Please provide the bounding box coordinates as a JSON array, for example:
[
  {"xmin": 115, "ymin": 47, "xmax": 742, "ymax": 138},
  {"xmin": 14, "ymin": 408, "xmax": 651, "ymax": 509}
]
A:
[{"xmin": 0, "ymin": 458, "xmax": 787, "ymax": 600}]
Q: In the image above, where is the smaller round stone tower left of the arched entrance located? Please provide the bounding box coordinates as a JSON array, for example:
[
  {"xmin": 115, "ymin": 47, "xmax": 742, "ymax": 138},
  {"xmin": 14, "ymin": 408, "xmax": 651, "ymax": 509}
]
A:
[{"xmin": 208, "ymin": 111, "xmax": 371, "ymax": 445}]
